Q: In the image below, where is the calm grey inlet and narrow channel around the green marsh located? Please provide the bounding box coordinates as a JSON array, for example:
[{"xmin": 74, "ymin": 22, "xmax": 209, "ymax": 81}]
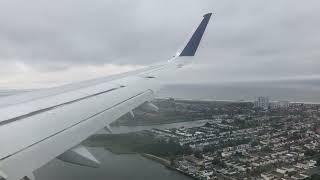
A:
[{"xmin": 35, "ymin": 120, "xmax": 202, "ymax": 180}]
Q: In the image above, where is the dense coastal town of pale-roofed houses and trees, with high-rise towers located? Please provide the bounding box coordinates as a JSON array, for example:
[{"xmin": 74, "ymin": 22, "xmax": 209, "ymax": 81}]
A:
[{"xmin": 146, "ymin": 100, "xmax": 320, "ymax": 180}]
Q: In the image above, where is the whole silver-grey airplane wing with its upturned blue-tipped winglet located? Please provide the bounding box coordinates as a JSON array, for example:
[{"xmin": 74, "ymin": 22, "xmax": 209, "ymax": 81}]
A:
[{"xmin": 0, "ymin": 13, "xmax": 211, "ymax": 180}]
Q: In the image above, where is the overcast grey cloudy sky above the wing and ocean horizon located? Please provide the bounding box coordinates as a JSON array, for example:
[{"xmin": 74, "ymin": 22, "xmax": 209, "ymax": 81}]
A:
[{"xmin": 0, "ymin": 0, "xmax": 320, "ymax": 88}]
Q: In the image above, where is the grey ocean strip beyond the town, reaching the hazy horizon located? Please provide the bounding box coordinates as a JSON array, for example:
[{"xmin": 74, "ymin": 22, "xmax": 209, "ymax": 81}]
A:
[{"xmin": 157, "ymin": 80, "xmax": 320, "ymax": 103}]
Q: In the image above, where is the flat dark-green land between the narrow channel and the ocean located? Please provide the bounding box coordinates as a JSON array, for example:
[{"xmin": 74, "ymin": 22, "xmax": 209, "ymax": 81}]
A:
[{"xmin": 111, "ymin": 98, "xmax": 245, "ymax": 126}]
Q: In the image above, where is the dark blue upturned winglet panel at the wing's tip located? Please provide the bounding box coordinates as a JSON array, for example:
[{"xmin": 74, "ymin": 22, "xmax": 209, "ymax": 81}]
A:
[{"xmin": 179, "ymin": 13, "xmax": 212, "ymax": 56}]
